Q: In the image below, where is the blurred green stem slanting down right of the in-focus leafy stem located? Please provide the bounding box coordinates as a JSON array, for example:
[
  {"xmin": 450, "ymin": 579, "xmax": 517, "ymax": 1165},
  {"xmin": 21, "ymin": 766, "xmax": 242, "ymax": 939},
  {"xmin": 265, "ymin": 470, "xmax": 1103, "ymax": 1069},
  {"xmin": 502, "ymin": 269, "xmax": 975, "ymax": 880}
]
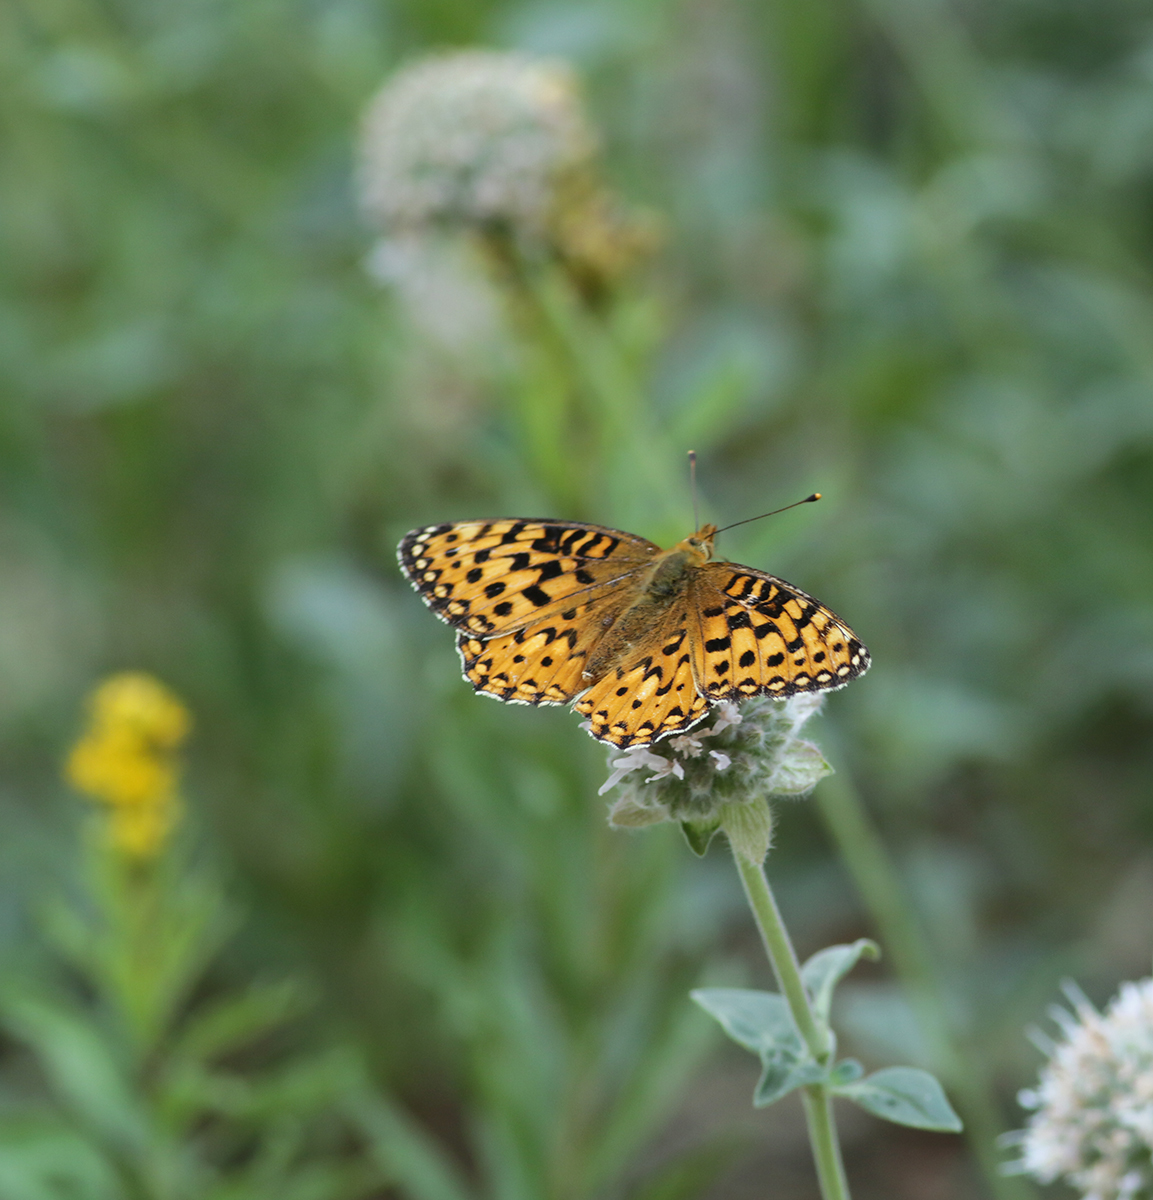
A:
[{"xmin": 816, "ymin": 772, "xmax": 1037, "ymax": 1200}]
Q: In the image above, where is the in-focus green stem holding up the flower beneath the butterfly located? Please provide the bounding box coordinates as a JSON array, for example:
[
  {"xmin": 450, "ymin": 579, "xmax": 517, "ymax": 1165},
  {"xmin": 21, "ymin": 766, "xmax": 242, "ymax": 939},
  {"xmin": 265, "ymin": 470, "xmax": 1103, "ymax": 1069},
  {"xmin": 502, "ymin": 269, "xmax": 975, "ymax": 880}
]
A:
[{"xmin": 733, "ymin": 848, "xmax": 849, "ymax": 1200}]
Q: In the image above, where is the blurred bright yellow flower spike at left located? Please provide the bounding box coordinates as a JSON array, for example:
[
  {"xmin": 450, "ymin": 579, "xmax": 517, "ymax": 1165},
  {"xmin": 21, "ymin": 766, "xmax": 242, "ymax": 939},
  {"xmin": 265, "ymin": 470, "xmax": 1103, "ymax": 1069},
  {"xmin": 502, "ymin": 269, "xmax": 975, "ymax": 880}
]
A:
[{"xmin": 65, "ymin": 672, "xmax": 192, "ymax": 858}]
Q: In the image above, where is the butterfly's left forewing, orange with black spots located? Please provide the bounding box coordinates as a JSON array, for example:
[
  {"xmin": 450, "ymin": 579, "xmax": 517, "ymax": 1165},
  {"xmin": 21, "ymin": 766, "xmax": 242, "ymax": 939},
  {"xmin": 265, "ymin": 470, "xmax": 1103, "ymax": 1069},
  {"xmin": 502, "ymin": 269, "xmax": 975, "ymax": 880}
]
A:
[{"xmin": 400, "ymin": 520, "xmax": 659, "ymax": 637}]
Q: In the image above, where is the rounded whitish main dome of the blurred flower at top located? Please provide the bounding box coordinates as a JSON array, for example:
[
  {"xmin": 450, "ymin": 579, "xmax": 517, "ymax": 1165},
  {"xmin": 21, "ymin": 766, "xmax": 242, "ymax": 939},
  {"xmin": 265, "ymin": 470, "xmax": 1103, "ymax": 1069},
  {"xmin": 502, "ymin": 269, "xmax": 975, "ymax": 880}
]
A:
[{"xmin": 360, "ymin": 50, "xmax": 596, "ymax": 240}]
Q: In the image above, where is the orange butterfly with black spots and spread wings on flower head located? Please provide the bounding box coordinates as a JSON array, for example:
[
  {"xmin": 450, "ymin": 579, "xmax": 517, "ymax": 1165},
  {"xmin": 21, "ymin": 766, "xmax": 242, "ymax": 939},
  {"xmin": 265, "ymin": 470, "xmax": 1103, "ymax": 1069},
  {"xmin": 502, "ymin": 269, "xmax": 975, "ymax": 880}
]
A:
[{"xmin": 397, "ymin": 517, "xmax": 869, "ymax": 748}]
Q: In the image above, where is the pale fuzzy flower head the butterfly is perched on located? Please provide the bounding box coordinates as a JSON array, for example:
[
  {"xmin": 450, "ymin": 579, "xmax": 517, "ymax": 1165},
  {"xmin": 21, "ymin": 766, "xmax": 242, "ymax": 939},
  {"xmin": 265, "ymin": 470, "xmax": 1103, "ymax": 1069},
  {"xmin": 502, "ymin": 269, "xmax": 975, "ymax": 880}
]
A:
[{"xmin": 600, "ymin": 696, "xmax": 830, "ymax": 830}]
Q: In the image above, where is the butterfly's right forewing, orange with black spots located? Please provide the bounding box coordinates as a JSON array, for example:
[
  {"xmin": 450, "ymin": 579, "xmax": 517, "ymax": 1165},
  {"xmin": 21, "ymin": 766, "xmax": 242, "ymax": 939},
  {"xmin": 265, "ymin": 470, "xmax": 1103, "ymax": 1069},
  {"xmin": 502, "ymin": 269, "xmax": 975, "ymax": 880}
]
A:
[{"xmin": 692, "ymin": 563, "xmax": 869, "ymax": 701}]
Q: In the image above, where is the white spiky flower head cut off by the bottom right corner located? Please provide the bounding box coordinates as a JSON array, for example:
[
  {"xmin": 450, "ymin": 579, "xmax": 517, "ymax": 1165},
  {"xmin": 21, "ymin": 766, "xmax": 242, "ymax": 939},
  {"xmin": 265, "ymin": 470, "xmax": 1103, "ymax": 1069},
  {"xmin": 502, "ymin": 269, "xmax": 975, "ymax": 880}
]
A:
[{"xmin": 1007, "ymin": 978, "xmax": 1153, "ymax": 1200}]
